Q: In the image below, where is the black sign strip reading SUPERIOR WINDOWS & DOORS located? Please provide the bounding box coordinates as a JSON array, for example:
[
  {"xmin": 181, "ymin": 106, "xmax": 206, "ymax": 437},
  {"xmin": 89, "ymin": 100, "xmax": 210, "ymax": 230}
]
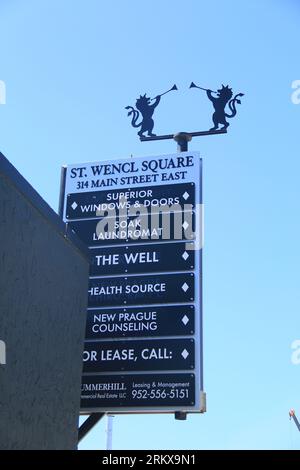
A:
[{"xmin": 66, "ymin": 183, "xmax": 195, "ymax": 220}]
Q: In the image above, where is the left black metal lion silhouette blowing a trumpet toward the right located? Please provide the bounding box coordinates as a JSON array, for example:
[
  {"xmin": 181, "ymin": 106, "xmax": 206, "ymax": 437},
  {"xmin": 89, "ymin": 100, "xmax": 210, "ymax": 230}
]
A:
[{"xmin": 125, "ymin": 85, "xmax": 178, "ymax": 137}]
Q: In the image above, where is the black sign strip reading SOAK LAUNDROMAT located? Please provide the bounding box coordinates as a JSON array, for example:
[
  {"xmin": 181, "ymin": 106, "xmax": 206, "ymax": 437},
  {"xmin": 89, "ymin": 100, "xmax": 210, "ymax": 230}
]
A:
[{"xmin": 68, "ymin": 212, "xmax": 195, "ymax": 247}]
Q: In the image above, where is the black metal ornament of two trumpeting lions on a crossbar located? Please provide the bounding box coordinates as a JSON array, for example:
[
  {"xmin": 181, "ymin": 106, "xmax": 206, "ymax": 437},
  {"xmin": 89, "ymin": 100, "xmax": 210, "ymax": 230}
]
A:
[{"xmin": 125, "ymin": 82, "xmax": 244, "ymax": 143}]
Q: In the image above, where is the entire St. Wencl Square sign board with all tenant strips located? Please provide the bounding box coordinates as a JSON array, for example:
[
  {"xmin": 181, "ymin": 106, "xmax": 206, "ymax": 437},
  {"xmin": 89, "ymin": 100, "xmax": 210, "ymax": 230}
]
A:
[{"xmin": 60, "ymin": 152, "xmax": 203, "ymax": 413}]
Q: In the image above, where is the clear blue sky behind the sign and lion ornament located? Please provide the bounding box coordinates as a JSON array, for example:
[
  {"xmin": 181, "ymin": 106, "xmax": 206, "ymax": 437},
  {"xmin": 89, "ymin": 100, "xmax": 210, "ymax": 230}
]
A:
[{"xmin": 0, "ymin": 0, "xmax": 300, "ymax": 449}]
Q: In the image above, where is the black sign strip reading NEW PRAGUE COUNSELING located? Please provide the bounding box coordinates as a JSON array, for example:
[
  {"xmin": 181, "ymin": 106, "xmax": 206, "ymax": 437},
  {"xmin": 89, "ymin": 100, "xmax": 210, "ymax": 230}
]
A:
[{"xmin": 85, "ymin": 305, "xmax": 195, "ymax": 340}]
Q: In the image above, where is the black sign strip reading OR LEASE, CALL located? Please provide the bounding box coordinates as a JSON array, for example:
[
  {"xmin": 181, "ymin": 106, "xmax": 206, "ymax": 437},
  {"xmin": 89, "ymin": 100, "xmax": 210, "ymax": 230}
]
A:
[{"xmin": 83, "ymin": 339, "xmax": 195, "ymax": 373}]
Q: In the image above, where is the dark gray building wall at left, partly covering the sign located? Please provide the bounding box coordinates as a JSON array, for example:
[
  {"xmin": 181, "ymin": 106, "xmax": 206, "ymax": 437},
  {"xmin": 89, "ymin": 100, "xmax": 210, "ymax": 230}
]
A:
[{"xmin": 0, "ymin": 154, "xmax": 89, "ymax": 449}]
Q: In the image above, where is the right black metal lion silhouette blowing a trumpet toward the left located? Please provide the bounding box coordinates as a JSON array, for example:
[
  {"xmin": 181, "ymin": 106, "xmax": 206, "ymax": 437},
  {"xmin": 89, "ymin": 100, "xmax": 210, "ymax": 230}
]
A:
[{"xmin": 190, "ymin": 82, "xmax": 244, "ymax": 131}]
